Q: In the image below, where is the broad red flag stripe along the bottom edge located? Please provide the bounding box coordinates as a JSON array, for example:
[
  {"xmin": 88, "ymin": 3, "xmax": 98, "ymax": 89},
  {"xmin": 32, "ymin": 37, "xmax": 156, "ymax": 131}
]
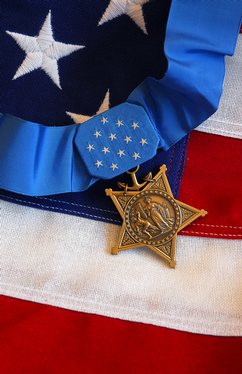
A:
[{"xmin": 0, "ymin": 297, "xmax": 242, "ymax": 374}]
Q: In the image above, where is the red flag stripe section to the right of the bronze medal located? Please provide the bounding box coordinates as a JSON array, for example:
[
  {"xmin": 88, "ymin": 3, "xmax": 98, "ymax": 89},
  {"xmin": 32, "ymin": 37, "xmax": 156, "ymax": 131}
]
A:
[{"xmin": 179, "ymin": 131, "xmax": 242, "ymax": 239}]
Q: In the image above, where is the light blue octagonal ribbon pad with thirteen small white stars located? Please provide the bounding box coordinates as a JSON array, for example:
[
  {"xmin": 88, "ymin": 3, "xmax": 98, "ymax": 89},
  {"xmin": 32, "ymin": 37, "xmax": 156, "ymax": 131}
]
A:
[{"xmin": 74, "ymin": 103, "xmax": 159, "ymax": 179}]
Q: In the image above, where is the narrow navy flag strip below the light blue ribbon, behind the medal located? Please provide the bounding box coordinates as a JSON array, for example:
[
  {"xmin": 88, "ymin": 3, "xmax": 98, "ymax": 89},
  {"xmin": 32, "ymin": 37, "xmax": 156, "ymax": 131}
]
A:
[{"xmin": 0, "ymin": 137, "xmax": 188, "ymax": 224}]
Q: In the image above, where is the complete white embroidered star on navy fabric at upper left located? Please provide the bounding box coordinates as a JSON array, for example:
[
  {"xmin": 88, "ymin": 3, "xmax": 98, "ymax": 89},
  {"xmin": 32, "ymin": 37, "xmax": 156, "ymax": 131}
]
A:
[{"xmin": 6, "ymin": 11, "xmax": 85, "ymax": 89}]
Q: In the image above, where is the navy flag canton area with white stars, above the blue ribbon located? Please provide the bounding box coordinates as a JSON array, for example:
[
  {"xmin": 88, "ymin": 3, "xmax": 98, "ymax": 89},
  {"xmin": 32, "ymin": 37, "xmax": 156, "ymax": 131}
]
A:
[{"xmin": 0, "ymin": 0, "xmax": 170, "ymax": 126}]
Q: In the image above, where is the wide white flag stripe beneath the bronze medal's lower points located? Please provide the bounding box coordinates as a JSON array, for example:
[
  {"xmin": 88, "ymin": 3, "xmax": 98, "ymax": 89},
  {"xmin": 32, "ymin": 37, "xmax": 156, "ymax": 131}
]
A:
[{"xmin": 0, "ymin": 201, "xmax": 242, "ymax": 336}]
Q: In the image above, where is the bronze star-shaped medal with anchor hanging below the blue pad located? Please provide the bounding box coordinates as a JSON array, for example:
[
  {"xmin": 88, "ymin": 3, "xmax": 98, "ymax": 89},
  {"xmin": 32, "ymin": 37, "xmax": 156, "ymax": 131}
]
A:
[{"xmin": 105, "ymin": 165, "xmax": 207, "ymax": 267}]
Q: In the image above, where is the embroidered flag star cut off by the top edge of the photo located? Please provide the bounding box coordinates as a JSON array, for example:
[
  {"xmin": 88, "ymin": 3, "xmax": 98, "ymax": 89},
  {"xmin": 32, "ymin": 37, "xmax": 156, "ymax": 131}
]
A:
[{"xmin": 98, "ymin": 0, "xmax": 150, "ymax": 34}]
